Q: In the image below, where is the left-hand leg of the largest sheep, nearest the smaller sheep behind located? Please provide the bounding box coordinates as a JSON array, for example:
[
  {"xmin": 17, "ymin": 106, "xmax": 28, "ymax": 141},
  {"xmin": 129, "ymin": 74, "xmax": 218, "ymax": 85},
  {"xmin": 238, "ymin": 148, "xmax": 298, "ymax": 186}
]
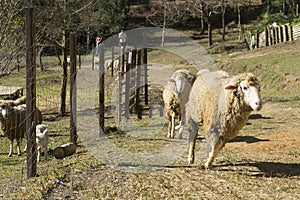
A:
[{"xmin": 188, "ymin": 120, "xmax": 198, "ymax": 165}]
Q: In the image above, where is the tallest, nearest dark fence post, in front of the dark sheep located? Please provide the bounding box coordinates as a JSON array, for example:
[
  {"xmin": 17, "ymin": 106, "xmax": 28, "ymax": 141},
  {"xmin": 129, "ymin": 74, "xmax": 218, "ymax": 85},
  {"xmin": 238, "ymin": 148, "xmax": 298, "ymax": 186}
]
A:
[{"xmin": 25, "ymin": 7, "xmax": 37, "ymax": 178}]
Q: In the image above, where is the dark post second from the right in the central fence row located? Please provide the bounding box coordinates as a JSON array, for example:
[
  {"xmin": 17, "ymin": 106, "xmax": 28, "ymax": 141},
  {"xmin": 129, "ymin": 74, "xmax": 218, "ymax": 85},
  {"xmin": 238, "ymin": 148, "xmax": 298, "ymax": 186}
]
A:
[{"xmin": 135, "ymin": 50, "xmax": 142, "ymax": 119}]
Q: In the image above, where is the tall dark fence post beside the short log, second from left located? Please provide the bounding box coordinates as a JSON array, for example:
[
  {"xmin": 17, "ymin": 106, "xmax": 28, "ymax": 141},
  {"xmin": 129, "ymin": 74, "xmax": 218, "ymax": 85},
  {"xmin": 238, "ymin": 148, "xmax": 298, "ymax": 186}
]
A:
[{"xmin": 70, "ymin": 33, "xmax": 77, "ymax": 145}]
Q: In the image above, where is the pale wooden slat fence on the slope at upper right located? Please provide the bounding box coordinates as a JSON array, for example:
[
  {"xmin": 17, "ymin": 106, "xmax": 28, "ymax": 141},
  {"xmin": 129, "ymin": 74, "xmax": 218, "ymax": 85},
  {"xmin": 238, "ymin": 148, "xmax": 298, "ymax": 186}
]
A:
[{"xmin": 250, "ymin": 25, "xmax": 300, "ymax": 49}]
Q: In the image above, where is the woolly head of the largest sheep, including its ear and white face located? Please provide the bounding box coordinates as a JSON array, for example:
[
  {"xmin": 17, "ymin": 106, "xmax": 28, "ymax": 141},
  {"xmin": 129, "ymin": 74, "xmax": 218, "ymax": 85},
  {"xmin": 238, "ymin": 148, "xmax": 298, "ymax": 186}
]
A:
[{"xmin": 225, "ymin": 73, "xmax": 262, "ymax": 111}]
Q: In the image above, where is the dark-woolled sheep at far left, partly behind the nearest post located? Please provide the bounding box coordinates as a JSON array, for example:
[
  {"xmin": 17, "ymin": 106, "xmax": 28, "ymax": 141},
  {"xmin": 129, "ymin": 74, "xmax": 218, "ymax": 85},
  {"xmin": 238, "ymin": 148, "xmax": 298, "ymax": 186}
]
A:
[{"xmin": 0, "ymin": 103, "xmax": 42, "ymax": 157}]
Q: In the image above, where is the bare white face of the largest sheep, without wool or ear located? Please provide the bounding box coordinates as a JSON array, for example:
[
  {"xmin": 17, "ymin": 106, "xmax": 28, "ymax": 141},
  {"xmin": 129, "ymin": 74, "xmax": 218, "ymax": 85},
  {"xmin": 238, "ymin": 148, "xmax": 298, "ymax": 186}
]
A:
[{"xmin": 239, "ymin": 80, "xmax": 262, "ymax": 111}]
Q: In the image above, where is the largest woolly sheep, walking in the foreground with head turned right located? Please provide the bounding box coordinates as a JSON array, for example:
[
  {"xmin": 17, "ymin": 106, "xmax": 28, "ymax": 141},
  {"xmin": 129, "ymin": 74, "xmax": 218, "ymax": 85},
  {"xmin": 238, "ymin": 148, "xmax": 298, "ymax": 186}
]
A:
[{"xmin": 186, "ymin": 70, "xmax": 262, "ymax": 169}]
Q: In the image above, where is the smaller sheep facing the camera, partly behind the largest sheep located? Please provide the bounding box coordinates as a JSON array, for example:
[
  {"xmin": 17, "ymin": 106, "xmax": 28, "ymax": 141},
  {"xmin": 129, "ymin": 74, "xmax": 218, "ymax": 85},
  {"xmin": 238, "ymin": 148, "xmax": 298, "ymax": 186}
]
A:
[{"xmin": 163, "ymin": 69, "xmax": 196, "ymax": 139}]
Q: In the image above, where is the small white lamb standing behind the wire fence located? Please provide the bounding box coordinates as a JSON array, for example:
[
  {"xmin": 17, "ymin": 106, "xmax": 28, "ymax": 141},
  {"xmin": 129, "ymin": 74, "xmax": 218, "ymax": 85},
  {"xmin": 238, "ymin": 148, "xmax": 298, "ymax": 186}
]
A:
[{"xmin": 36, "ymin": 124, "xmax": 49, "ymax": 162}]
